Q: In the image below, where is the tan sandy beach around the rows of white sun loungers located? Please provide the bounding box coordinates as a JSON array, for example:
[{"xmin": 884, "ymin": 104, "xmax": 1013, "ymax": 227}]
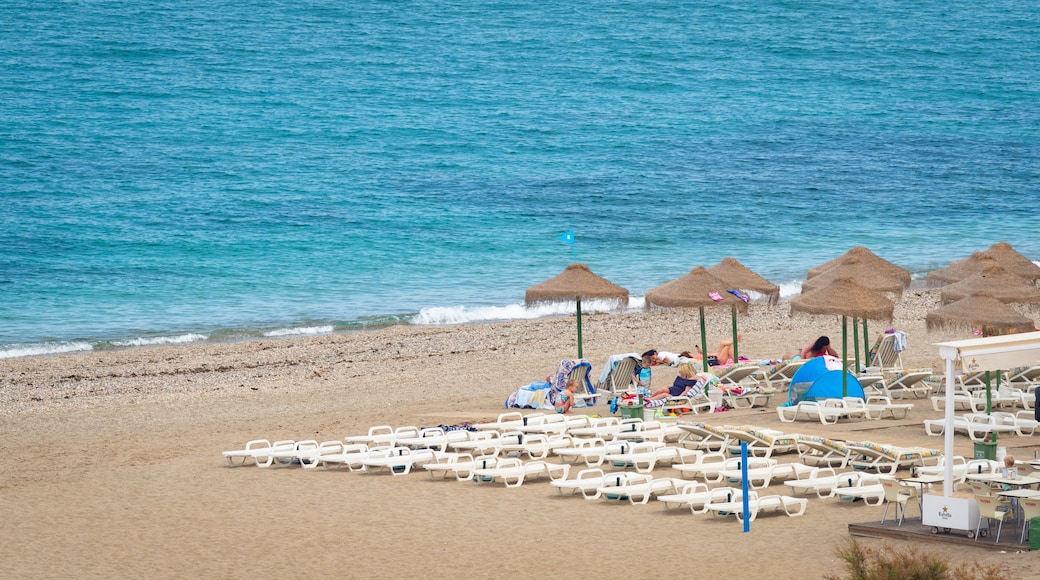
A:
[{"xmin": 0, "ymin": 290, "xmax": 1040, "ymax": 578}]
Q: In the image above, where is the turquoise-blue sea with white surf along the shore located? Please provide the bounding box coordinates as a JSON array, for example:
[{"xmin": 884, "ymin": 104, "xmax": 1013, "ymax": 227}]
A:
[{"xmin": 0, "ymin": 0, "xmax": 1040, "ymax": 358}]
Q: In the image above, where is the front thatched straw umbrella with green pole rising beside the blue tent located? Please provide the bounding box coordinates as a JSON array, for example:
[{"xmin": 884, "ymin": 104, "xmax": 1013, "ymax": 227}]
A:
[{"xmin": 790, "ymin": 278, "xmax": 895, "ymax": 396}]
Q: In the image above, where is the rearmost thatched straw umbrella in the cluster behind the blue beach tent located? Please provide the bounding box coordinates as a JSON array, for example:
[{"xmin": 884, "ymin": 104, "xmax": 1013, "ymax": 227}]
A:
[{"xmin": 802, "ymin": 252, "xmax": 910, "ymax": 367}]
